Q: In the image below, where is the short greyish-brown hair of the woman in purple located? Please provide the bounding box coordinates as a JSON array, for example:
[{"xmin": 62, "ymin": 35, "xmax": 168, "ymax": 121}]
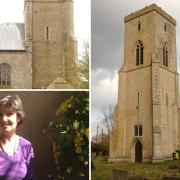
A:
[{"xmin": 0, "ymin": 95, "xmax": 25, "ymax": 126}]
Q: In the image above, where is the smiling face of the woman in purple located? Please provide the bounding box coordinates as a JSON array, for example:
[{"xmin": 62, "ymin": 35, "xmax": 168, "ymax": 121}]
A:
[{"xmin": 0, "ymin": 106, "xmax": 18, "ymax": 132}]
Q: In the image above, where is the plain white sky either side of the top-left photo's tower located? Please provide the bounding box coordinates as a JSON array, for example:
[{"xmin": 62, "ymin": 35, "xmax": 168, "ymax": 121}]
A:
[{"xmin": 0, "ymin": 0, "xmax": 90, "ymax": 54}]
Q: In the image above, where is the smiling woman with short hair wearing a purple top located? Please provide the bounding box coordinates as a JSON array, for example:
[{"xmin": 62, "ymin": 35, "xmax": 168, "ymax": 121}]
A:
[{"xmin": 0, "ymin": 96, "xmax": 35, "ymax": 180}]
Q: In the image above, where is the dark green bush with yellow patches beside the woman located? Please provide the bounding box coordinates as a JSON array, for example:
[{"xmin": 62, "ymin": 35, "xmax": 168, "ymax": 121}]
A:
[{"xmin": 46, "ymin": 92, "xmax": 89, "ymax": 180}]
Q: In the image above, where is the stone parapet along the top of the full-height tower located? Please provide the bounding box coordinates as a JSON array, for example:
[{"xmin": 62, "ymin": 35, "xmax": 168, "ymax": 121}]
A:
[{"xmin": 124, "ymin": 4, "xmax": 176, "ymax": 26}]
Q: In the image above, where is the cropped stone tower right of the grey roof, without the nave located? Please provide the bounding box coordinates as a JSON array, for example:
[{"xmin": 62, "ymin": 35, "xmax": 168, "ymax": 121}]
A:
[{"xmin": 24, "ymin": 0, "xmax": 77, "ymax": 88}]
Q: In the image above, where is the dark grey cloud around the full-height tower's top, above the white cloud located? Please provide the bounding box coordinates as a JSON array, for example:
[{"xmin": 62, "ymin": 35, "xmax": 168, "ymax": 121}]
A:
[{"xmin": 91, "ymin": 0, "xmax": 180, "ymax": 71}]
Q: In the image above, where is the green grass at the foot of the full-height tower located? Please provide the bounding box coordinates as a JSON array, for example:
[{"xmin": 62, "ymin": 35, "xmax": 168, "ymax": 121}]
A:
[{"xmin": 92, "ymin": 156, "xmax": 180, "ymax": 180}]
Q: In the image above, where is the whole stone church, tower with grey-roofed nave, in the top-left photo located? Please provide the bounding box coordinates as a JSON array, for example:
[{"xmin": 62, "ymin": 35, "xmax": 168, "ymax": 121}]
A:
[{"xmin": 0, "ymin": 0, "xmax": 77, "ymax": 89}]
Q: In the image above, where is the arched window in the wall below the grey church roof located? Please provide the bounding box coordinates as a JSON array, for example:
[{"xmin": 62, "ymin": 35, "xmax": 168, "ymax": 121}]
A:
[{"xmin": 0, "ymin": 63, "xmax": 11, "ymax": 86}]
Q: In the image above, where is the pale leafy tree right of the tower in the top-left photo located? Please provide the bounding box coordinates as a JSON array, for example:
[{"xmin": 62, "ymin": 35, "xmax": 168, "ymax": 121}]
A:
[{"xmin": 78, "ymin": 41, "xmax": 89, "ymax": 89}]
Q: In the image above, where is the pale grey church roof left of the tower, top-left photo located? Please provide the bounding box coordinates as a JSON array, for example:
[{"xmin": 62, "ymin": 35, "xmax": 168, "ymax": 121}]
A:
[{"xmin": 0, "ymin": 23, "xmax": 25, "ymax": 51}]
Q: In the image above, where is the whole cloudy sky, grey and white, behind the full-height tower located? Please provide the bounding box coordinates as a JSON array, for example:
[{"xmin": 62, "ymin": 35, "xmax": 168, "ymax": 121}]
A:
[{"xmin": 91, "ymin": 0, "xmax": 180, "ymax": 135}]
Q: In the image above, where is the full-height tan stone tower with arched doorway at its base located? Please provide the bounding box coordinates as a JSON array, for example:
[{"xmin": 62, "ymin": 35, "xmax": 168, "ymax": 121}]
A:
[{"xmin": 109, "ymin": 4, "xmax": 180, "ymax": 163}]
